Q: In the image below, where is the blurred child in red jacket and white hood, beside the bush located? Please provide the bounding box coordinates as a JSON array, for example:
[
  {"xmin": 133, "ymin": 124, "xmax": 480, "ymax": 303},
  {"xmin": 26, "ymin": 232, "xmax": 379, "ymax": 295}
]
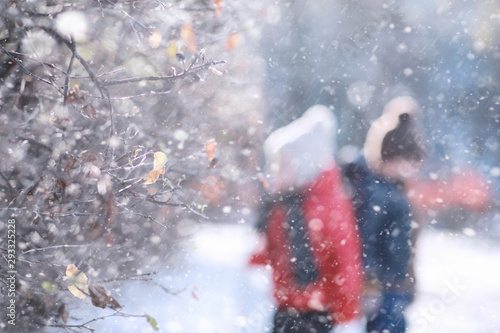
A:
[{"xmin": 251, "ymin": 106, "xmax": 363, "ymax": 333}]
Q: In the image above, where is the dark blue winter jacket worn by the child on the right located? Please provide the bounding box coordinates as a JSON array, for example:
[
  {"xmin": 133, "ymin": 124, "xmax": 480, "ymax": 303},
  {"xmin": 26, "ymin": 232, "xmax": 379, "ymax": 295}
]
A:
[{"xmin": 344, "ymin": 157, "xmax": 411, "ymax": 287}]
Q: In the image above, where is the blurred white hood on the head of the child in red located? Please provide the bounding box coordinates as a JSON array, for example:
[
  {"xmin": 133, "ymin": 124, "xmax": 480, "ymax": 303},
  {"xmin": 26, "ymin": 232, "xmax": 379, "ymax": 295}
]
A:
[{"xmin": 264, "ymin": 105, "xmax": 337, "ymax": 193}]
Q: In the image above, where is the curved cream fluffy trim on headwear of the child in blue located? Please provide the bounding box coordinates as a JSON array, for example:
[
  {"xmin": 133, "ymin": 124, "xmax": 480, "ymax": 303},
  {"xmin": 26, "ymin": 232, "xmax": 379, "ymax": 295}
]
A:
[{"xmin": 363, "ymin": 96, "xmax": 421, "ymax": 174}]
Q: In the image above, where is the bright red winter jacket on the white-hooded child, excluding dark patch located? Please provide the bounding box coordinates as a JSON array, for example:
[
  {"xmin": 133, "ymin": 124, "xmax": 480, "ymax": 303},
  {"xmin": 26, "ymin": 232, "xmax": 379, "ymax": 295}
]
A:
[{"xmin": 250, "ymin": 166, "xmax": 363, "ymax": 323}]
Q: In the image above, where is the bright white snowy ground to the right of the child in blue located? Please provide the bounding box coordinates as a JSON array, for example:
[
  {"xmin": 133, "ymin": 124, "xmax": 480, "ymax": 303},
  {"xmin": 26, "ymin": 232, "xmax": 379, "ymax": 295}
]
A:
[{"xmin": 408, "ymin": 230, "xmax": 500, "ymax": 333}]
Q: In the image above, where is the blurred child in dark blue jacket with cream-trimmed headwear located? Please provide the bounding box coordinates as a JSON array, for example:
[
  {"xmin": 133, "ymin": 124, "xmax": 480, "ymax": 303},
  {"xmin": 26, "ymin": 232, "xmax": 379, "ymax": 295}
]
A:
[{"xmin": 344, "ymin": 96, "xmax": 424, "ymax": 333}]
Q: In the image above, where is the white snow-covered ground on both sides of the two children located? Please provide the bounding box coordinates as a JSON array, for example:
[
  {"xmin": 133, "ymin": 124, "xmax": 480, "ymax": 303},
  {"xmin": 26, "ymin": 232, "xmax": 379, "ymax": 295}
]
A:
[{"xmin": 71, "ymin": 220, "xmax": 500, "ymax": 333}]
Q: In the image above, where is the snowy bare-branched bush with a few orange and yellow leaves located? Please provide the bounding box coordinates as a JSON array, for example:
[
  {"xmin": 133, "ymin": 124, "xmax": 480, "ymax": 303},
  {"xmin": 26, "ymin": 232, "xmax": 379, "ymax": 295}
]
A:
[{"xmin": 0, "ymin": 0, "xmax": 260, "ymax": 331}]
